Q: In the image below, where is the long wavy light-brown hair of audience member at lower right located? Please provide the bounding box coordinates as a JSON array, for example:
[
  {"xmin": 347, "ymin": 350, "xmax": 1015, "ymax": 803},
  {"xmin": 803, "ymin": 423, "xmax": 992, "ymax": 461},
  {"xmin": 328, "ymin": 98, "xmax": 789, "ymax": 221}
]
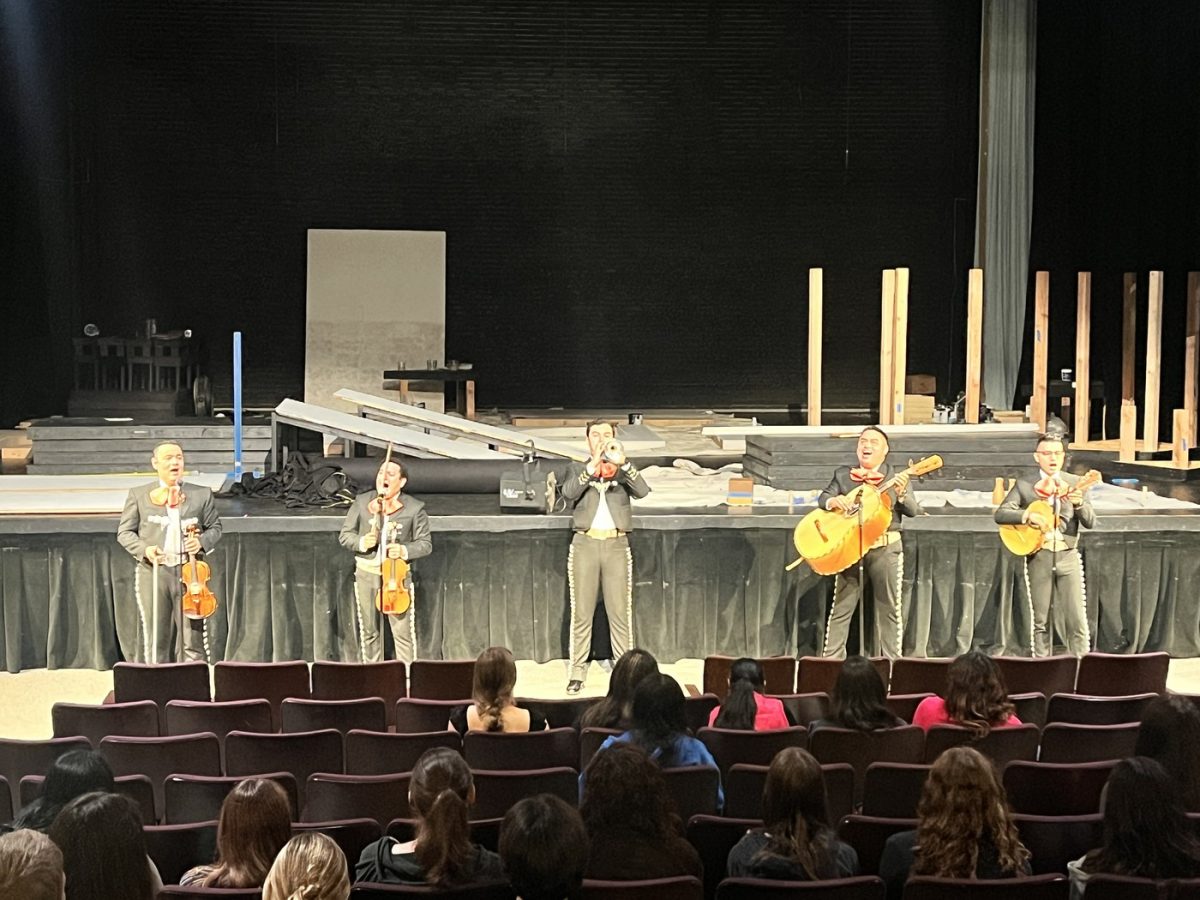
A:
[{"xmin": 912, "ymin": 746, "xmax": 1030, "ymax": 878}]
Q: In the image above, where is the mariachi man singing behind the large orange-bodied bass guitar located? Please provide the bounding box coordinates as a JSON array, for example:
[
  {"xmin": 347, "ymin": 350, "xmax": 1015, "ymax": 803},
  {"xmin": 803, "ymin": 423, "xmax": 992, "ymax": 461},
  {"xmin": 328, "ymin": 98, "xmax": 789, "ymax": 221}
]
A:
[{"xmin": 817, "ymin": 425, "xmax": 920, "ymax": 659}]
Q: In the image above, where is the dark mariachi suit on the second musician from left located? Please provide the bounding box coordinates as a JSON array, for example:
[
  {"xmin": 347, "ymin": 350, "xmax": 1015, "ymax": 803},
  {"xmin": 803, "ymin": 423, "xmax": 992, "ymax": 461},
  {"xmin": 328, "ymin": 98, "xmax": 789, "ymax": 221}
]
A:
[{"xmin": 338, "ymin": 491, "xmax": 433, "ymax": 664}]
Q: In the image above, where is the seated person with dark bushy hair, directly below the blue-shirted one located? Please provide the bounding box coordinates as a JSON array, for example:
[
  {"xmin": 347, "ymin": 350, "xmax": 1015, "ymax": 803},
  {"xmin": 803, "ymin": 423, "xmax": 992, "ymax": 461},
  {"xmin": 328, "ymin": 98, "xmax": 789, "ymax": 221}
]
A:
[{"xmin": 580, "ymin": 744, "xmax": 704, "ymax": 881}]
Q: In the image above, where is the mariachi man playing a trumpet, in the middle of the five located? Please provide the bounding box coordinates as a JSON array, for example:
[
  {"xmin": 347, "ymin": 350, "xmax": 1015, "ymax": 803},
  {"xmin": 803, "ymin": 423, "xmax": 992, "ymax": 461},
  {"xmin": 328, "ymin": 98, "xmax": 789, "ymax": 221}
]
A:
[{"xmin": 563, "ymin": 420, "xmax": 650, "ymax": 694}]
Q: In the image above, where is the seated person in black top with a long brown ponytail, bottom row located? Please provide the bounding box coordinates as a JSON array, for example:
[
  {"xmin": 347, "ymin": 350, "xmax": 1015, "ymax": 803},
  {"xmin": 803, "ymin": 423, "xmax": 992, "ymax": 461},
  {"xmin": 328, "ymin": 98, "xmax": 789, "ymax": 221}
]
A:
[{"xmin": 354, "ymin": 746, "xmax": 504, "ymax": 887}]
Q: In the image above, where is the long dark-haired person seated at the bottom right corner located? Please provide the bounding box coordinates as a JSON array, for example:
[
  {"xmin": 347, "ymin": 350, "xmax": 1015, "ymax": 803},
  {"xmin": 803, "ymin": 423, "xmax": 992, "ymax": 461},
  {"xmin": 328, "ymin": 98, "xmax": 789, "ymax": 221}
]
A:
[{"xmin": 1067, "ymin": 756, "xmax": 1200, "ymax": 900}]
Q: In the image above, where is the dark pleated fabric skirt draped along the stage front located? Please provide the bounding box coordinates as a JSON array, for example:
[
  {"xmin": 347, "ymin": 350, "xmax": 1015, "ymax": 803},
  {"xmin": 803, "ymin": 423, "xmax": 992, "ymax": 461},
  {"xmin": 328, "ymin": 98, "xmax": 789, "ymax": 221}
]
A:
[{"xmin": 0, "ymin": 518, "xmax": 1200, "ymax": 672}]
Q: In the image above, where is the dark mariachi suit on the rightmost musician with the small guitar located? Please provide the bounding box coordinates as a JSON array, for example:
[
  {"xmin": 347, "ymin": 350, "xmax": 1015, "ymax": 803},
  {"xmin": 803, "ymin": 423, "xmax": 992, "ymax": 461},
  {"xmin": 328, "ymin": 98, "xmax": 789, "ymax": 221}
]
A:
[{"xmin": 995, "ymin": 472, "xmax": 1096, "ymax": 656}]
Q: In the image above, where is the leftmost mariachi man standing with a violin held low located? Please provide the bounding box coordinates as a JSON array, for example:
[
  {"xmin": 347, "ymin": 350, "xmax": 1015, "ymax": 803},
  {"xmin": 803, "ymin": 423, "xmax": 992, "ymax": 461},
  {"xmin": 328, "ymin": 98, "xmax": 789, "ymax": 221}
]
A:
[{"xmin": 116, "ymin": 442, "xmax": 221, "ymax": 662}]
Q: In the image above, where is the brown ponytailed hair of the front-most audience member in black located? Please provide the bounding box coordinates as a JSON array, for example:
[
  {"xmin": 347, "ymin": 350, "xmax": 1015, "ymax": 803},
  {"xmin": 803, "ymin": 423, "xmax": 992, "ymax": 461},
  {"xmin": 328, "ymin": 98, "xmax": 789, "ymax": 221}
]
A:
[{"xmin": 408, "ymin": 746, "xmax": 475, "ymax": 886}]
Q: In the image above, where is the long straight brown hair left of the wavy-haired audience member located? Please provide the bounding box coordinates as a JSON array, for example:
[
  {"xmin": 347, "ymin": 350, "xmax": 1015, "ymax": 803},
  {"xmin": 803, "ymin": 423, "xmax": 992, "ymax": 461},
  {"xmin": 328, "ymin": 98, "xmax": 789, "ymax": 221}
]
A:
[{"xmin": 756, "ymin": 746, "xmax": 838, "ymax": 881}]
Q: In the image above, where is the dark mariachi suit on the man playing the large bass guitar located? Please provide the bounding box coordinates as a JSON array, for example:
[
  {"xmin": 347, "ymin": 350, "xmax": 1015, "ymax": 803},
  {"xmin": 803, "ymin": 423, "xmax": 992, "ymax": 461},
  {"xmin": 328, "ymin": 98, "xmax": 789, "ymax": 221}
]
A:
[{"xmin": 817, "ymin": 462, "xmax": 920, "ymax": 659}]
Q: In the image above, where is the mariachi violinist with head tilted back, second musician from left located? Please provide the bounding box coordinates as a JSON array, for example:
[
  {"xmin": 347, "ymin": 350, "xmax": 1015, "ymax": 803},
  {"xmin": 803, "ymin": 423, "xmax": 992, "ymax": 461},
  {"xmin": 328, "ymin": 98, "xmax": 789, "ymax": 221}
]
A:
[{"xmin": 338, "ymin": 460, "xmax": 433, "ymax": 664}]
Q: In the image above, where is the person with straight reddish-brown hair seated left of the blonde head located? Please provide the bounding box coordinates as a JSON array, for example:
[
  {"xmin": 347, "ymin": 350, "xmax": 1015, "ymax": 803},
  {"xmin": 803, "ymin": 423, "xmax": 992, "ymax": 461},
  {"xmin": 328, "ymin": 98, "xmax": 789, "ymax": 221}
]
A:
[{"xmin": 179, "ymin": 779, "xmax": 292, "ymax": 888}]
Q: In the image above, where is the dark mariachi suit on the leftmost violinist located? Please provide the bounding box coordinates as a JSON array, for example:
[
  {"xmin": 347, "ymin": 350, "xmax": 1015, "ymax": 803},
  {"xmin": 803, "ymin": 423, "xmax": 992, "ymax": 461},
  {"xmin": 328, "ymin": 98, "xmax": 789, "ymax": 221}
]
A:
[{"xmin": 116, "ymin": 482, "xmax": 221, "ymax": 662}]
